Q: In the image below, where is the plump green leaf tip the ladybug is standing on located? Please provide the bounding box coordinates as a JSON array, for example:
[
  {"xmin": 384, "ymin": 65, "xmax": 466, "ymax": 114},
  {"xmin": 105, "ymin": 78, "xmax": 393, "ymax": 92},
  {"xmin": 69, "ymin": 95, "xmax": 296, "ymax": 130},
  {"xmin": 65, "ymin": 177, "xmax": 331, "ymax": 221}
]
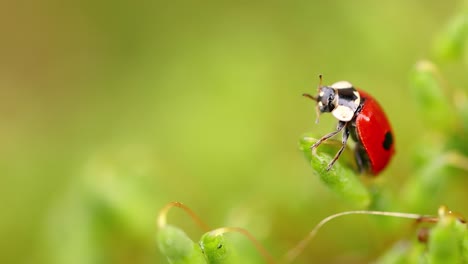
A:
[{"xmin": 300, "ymin": 135, "xmax": 371, "ymax": 208}]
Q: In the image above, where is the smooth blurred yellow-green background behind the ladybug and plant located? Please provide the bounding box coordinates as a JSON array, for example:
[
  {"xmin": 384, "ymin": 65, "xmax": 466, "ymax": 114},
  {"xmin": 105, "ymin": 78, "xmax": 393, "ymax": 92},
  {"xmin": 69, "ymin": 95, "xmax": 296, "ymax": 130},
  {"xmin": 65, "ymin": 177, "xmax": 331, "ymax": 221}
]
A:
[{"xmin": 0, "ymin": 0, "xmax": 468, "ymax": 263}]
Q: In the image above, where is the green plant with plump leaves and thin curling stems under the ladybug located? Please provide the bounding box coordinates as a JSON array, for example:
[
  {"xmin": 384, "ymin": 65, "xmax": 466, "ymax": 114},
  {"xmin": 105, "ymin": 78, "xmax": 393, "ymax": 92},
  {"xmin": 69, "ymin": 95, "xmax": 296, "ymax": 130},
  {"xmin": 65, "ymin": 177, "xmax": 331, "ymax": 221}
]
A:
[{"xmin": 158, "ymin": 6, "xmax": 468, "ymax": 263}]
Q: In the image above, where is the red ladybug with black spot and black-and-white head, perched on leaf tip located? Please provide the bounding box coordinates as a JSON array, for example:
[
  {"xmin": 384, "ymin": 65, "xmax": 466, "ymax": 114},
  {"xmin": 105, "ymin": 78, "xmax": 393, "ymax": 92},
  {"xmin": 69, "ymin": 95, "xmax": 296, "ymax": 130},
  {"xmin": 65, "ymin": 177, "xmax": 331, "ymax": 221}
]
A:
[{"xmin": 303, "ymin": 76, "xmax": 395, "ymax": 175}]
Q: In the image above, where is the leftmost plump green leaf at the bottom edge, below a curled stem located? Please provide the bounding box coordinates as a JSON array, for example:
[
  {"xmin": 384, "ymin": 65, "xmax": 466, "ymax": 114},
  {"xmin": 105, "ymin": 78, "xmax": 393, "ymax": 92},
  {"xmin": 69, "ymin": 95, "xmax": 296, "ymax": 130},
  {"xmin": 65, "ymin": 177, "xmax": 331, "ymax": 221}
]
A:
[{"xmin": 157, "ymin": 225, "xmax": 206, "ymax": 264}]
